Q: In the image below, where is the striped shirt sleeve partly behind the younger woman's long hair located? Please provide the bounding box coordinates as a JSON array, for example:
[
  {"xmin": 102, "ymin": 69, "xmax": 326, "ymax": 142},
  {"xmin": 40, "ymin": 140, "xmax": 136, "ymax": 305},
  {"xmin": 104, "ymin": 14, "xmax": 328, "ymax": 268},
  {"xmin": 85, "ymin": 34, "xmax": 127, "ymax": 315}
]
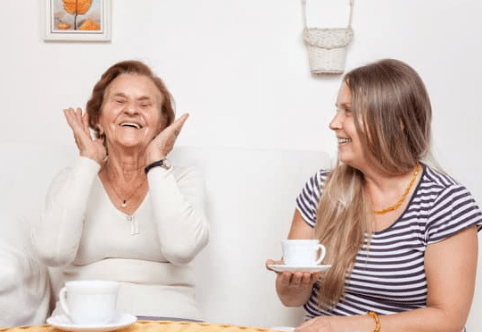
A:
[{"xmin": 296, "ymin": 170, "xmax": 326, "ymax": 227}]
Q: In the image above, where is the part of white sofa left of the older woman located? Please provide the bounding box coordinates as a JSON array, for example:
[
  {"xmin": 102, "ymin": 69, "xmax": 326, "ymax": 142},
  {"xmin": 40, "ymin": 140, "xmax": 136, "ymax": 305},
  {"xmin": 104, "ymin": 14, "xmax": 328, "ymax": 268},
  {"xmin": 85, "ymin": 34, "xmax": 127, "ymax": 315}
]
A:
[{"xmin": 0, "ymin": 143, "xmax": 68, "ymax": 327}]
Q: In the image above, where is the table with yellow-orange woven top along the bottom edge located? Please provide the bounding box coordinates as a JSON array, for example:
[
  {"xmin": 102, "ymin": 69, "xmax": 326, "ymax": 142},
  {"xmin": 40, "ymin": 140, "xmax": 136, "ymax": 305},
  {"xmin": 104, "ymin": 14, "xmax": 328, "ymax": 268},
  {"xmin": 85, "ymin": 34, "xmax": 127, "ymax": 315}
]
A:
[{"xmin": 0, "ymin": 320, "xmax": 282, "ymax": 332}]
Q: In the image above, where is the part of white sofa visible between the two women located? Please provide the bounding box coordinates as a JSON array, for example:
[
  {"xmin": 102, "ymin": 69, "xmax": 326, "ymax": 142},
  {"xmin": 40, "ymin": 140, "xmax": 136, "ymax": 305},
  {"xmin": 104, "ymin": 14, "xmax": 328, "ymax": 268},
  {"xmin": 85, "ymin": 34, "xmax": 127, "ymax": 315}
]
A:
[{"xmin": 172, "ymin": 148, "xmax": 330, "ymax": 327}]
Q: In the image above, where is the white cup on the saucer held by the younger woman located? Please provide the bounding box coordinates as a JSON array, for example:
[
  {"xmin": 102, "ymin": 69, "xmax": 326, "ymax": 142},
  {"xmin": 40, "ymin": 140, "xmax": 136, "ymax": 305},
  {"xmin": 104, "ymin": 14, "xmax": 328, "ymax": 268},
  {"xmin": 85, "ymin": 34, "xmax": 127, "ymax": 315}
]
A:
[{"xmin": 281, "ymin": 240, "xmax": 326, "ymax": 267}]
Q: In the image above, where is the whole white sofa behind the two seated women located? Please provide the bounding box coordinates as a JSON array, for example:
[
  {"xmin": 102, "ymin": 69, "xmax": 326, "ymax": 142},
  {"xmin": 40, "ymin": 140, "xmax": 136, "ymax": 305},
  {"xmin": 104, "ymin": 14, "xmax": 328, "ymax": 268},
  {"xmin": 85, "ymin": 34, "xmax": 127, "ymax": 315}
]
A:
[{"xmin": 0, "ymin": 143, "xmax": 482, "ymax": 331}]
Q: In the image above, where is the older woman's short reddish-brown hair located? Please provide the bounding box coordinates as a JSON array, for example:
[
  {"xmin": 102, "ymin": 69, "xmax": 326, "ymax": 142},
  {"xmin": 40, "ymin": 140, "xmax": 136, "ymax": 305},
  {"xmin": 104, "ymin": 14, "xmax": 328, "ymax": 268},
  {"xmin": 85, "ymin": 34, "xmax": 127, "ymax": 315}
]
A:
[{"xmin": 86, "ymin": 60, "xmax": 175, "ymax": 137}]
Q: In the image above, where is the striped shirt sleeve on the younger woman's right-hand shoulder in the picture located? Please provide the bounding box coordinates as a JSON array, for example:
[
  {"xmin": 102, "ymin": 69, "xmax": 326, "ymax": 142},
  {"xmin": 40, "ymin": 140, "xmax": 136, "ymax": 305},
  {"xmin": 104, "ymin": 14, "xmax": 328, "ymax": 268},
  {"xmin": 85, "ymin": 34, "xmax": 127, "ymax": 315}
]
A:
[{"xmin": 425, "ymin": 184, "xmax": 482, "ymax": 244}]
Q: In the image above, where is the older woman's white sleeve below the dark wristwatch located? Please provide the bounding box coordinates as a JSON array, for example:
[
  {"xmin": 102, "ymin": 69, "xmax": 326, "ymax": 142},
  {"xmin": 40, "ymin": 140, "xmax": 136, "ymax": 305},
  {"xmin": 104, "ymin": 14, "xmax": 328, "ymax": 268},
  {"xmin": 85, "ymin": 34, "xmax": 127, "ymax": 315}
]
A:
[{"xmin": 148, "ymin": 167, "xmax": 209, "ymax": 264}]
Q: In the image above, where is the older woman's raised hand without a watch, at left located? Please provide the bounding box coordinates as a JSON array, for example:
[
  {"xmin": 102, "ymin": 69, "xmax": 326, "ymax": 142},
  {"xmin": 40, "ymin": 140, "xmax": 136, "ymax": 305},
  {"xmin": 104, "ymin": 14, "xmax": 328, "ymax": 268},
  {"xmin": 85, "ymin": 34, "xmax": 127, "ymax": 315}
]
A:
[{"xmin": 64, "ymin": 108, "xmax": 107, "ymax": 165}]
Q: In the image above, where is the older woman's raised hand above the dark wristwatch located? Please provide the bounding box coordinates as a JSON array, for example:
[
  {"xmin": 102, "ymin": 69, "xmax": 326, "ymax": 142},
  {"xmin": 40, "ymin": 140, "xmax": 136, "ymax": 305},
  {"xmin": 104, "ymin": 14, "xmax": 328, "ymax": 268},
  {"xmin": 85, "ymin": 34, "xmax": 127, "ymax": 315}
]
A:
[{"xmin": 145, "ymin": 113, "xmax": 189, "ymax": 165}]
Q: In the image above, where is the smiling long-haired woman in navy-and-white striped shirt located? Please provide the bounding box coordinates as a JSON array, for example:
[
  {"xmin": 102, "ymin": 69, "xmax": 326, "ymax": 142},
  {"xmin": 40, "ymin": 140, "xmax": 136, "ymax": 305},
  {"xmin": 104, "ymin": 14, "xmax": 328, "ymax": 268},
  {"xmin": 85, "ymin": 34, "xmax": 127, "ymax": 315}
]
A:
[{"xmin": 267, "ymin": 59, "xmax": 482, "ymax": 332}]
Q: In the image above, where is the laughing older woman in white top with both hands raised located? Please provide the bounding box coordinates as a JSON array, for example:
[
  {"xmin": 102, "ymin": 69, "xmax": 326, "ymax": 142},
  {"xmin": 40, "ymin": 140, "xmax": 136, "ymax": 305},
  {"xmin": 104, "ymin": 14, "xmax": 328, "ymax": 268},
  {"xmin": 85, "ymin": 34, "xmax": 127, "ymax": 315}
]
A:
[{"xmin": 32, "ymin": 61, "xmax": 209, "ymax": 320}]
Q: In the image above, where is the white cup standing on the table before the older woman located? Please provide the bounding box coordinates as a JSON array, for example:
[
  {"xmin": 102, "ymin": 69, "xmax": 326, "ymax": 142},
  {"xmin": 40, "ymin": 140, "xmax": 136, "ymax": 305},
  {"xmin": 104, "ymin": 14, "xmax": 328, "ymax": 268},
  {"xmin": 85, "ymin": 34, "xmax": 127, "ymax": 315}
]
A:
[{"xmin": 59, "ymin": 280, "xmax": 119, "ymax": 325}]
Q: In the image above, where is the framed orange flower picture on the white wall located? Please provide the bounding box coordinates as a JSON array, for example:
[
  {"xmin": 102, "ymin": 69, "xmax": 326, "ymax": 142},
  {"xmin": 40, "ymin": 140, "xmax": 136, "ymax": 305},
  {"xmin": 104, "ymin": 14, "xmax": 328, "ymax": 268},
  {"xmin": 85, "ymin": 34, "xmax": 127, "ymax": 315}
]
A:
[{"xmin": 41, "ymin": 0, "xmax": 111, "ymax": 42}]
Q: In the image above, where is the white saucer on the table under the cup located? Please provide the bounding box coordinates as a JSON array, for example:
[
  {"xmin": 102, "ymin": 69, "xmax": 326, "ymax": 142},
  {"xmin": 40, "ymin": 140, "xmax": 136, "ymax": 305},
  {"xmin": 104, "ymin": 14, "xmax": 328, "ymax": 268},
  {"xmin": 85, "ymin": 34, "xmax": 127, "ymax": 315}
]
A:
[{"xmin": 47, "ymin": 314, "xmax": 137, "ymax": 332}]
